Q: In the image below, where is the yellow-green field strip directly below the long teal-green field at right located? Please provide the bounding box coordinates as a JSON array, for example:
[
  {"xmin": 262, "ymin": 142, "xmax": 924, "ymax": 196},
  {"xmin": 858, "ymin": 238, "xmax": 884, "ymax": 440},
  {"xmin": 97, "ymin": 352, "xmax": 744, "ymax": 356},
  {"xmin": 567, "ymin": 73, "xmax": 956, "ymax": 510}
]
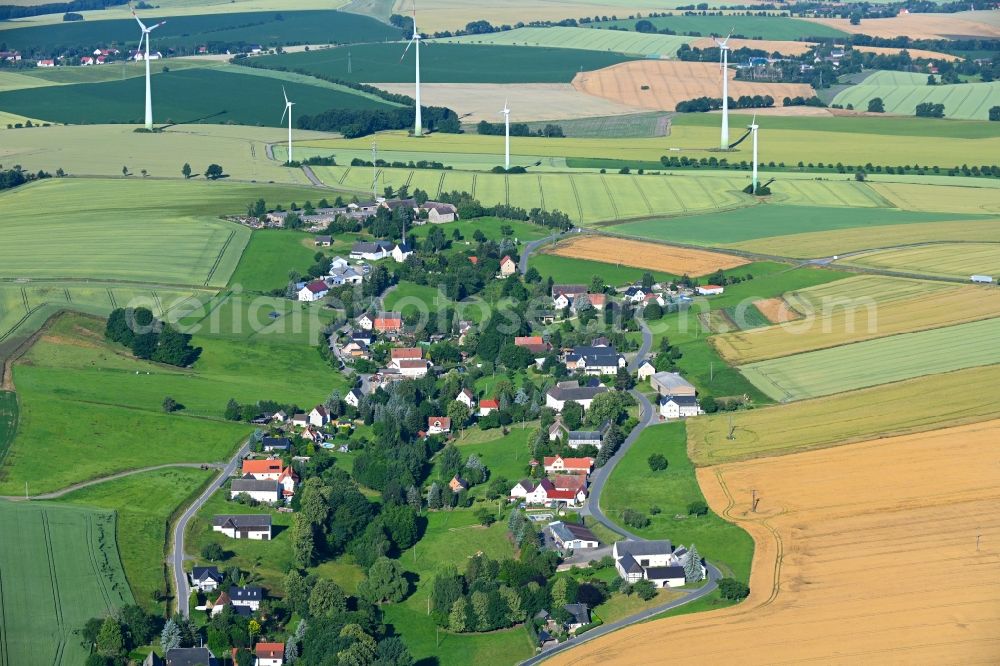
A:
[{"xmin": 725, "ymin": 219, "xmax": 1000, "ymax": 258}]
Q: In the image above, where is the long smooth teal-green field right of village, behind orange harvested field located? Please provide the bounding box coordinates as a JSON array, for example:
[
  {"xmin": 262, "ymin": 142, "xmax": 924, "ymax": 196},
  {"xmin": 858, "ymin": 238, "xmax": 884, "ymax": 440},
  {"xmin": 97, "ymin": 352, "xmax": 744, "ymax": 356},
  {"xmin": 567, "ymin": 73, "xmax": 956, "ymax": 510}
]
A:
[{"xmin": 607, "ymin": 205, "xmax": 968, "ymax": 248}]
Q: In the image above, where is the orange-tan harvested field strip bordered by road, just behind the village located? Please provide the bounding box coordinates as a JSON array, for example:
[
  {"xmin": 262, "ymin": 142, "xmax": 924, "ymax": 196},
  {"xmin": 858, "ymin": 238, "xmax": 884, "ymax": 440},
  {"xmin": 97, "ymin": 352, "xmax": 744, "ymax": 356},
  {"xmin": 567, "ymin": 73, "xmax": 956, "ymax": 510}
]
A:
[{"xmin": 547, "ymin": 236, "xmax": 750, "ymax": 277}]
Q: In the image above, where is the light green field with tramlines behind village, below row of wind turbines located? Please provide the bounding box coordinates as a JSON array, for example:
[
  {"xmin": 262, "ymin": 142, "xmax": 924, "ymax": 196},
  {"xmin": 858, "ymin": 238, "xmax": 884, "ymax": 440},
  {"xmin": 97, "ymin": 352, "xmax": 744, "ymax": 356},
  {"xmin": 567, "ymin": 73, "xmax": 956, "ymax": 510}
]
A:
[{"xmin": 313, "ymin": 166, "xmax": 751, "ymax": 224}]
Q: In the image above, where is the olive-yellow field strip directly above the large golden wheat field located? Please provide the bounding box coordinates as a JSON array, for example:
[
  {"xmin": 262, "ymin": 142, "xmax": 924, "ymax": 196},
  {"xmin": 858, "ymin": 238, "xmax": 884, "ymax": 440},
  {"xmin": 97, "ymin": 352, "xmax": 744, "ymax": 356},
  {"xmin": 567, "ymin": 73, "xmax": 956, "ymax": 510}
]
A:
[{"xmin": 687, "ymin": 365, "xmax": 1000, "ymax": 465}]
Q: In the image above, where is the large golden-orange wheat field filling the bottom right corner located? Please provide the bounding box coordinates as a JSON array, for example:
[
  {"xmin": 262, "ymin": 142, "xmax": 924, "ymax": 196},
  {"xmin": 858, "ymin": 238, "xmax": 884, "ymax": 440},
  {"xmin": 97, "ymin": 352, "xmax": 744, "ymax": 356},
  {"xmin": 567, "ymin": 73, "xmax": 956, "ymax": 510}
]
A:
[{"xmin": 547, "ymin": 421, "xmax": 1000, "ymax": 665}]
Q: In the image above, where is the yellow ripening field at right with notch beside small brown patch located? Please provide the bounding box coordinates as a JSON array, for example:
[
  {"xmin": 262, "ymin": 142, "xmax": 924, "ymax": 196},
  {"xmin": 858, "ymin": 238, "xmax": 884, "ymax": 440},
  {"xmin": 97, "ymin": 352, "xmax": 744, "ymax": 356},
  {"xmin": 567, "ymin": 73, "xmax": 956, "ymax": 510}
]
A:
[{"xmin": 712, "ymin": 275, "xmax": 1000, "ymax": 365}]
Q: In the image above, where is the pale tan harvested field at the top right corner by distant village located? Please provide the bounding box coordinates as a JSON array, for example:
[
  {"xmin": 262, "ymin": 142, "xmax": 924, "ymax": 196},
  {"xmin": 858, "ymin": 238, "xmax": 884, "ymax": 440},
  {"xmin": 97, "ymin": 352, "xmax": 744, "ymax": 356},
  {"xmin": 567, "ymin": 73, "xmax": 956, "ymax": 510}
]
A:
[{"xmin": 805, "ymin": 11, "xmax": 1000, "ymax": 39}]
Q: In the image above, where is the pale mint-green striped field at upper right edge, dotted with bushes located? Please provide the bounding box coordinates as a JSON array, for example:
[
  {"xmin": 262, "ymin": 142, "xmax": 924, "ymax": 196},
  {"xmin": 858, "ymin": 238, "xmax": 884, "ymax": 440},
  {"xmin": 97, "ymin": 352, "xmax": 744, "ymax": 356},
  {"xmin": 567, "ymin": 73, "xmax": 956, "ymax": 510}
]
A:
[{"xmin": 833, "ymin": 72, "xmax": 1000, "ymax": 120}]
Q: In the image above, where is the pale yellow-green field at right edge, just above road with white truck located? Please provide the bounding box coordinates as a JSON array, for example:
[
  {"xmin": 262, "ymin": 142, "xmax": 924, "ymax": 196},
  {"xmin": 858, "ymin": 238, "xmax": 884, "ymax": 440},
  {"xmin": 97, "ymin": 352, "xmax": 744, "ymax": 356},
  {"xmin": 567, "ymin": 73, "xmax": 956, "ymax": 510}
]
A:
[{"xmin": 842, "ymin": 242, "xmax": 1000, "ymax": 280}]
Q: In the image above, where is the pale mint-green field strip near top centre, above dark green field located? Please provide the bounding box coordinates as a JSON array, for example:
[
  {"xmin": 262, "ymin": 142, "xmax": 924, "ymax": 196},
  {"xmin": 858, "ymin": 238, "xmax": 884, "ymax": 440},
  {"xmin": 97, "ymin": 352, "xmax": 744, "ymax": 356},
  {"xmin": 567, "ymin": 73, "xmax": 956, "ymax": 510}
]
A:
[{"xmin": 433, "ymin": 26, "xmax": 693, "ymax": 56}]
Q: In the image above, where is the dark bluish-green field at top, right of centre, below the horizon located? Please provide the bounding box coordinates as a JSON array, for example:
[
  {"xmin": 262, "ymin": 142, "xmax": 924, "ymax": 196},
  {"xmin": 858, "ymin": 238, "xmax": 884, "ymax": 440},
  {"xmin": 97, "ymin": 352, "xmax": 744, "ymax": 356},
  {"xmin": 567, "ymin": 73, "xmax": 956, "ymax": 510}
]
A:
[{"xmin": 594, "ymin": 14, "xmax": 845, "ymax": 40}]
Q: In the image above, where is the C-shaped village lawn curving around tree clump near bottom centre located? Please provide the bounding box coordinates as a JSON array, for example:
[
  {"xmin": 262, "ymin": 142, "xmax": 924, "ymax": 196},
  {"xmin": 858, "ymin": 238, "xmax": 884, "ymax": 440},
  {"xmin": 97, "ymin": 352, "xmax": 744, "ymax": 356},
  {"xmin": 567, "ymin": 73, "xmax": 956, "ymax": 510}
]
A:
[{"xmin": 382, "ymin": 509, "xmax": 534, "ymax": 666}]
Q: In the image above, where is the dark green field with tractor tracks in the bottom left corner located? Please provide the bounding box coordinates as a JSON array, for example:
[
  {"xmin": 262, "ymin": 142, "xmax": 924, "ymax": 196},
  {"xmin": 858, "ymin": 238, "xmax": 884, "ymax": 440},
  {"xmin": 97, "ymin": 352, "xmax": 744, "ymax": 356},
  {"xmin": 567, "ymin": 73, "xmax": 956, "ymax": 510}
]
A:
[{"xmin": 0, "ymin": 500, "xmax": 133, "ymax": 666}]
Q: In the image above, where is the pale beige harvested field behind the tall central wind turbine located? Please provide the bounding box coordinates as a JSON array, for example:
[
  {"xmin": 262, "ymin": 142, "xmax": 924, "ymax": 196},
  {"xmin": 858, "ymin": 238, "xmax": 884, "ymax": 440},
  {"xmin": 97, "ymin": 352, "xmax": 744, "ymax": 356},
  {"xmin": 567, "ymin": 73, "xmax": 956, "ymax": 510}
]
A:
[{"xmin": 373, "ymin": 83, "xmax": 642, "ymax": 123}]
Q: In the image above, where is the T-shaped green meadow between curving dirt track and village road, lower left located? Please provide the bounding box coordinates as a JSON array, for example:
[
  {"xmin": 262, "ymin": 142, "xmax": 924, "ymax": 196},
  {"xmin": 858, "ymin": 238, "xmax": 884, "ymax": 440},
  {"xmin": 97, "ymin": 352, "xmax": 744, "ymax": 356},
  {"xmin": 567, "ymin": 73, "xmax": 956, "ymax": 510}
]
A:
[{"xmin": 58, "ymin": 467, "xmax": 215, "ymax": 612}]
